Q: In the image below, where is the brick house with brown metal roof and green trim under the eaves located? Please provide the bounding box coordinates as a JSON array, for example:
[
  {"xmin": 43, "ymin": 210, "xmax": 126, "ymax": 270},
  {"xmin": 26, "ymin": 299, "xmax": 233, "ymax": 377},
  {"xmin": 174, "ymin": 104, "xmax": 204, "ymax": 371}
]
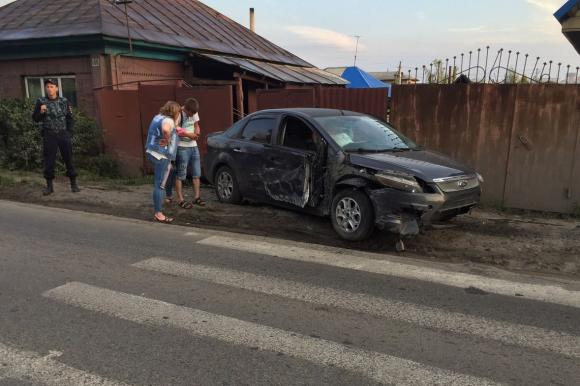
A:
[{"xmin": 0, "ymin": 0, "xmax": 346, "ymax": 117}]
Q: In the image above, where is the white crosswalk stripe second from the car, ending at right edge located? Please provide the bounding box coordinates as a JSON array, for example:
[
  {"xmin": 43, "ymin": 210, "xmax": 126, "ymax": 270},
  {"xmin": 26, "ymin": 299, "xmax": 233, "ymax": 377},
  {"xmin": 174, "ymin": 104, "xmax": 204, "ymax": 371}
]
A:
[{"xmin": 133, "ymin": 258, "xmax": 580, "ymax": 358}]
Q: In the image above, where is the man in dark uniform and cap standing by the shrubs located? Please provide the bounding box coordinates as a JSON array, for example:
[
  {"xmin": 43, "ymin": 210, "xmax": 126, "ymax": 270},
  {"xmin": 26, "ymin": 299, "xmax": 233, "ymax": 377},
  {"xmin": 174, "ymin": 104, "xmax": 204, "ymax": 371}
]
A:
[{"xmin": 32, "ymin": 78, "xmax": 80, "ymax": 196}]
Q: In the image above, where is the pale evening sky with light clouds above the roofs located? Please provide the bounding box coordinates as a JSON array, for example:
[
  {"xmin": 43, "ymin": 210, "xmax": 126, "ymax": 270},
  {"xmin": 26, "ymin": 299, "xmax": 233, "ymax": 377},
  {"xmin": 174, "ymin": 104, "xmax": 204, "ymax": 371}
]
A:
[{"xmin": 0, "ymin": 0, "xmax": 580, "ymax": 71}]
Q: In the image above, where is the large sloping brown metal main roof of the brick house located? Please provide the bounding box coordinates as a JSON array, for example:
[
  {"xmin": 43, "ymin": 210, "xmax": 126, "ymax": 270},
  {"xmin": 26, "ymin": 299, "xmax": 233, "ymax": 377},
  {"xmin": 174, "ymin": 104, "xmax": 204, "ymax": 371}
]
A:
[{"xmin": 0, "ymin": 0, "xmax": 312, "ymax": 67}]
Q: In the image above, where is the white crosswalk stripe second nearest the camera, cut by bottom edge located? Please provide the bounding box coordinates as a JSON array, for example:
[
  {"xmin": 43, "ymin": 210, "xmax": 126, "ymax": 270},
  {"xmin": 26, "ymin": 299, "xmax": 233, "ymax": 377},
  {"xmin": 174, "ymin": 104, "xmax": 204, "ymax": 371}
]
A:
[{"xmin": 44, "ymin": 282, "xmax": 497, "ymax": 385}]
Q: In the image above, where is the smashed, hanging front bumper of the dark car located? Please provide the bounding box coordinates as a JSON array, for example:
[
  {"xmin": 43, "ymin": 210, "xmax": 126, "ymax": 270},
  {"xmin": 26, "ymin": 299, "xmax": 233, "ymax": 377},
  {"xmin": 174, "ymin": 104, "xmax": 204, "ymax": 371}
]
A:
[{"xmin": 367, "ymin": 187, "xmax": 481, "ymax": 236}]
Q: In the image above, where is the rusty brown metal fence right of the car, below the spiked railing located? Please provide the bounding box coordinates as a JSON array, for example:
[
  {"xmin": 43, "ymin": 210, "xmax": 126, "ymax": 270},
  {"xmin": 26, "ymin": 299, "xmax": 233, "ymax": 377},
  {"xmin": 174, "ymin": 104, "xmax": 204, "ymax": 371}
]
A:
[{"xmin": 390, "ymin": 84, "xmax": 580, "ymax": 213}]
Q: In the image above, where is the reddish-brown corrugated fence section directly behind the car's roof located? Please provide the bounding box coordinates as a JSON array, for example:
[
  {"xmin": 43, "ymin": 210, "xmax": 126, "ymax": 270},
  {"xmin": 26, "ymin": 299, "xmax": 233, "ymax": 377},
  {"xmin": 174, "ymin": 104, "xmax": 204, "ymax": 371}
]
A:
[{"xmin": 249, "ymin": 87, "xmax": 388, "ymax": 119}]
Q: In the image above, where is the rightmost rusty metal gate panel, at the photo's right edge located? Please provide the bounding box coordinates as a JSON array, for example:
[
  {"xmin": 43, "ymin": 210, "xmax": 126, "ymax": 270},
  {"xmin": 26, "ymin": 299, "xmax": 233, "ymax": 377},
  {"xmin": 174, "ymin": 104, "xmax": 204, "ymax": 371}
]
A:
[{"xmin": 504, "ymin": 85, "xmax": 580, "ymax": 213}]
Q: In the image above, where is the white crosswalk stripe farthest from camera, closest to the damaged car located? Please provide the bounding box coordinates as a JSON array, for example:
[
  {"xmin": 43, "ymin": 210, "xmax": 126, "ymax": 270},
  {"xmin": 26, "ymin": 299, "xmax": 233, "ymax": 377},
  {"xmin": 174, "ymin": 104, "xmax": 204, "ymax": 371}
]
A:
[{"xmin": 197, "ymin": 236, "xmax": 580, "ymax": 308}]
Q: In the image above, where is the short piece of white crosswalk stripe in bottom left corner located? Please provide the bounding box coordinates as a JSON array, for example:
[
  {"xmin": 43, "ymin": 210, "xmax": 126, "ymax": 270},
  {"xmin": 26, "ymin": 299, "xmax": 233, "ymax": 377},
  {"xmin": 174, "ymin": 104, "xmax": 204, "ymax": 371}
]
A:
[{"xmin": 0, "ymin": 343, "xmax": 127, "ymax": 386}]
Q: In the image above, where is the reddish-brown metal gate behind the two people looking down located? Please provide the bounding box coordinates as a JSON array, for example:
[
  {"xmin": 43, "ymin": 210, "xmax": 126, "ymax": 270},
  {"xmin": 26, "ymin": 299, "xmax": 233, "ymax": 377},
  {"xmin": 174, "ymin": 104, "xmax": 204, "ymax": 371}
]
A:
[{"xmin": 96, "ymin": 86, "xmax": 233, "ymax": 176}]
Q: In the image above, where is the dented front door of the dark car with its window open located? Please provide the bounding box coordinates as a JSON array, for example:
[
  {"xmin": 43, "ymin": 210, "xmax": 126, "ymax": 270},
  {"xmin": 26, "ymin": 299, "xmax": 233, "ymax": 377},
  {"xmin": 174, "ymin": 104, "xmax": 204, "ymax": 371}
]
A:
[{"xmin": 263, "ymin": 115, "xmax": 326, "ymax": 208}]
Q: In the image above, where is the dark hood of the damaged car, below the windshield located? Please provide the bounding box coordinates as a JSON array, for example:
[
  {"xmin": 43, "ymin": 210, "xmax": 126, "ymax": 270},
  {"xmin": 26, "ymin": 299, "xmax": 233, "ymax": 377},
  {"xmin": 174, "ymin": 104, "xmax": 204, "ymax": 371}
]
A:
[{"xmin": 349, "ymin": 150, "xmax": 475, "ymax": 182}]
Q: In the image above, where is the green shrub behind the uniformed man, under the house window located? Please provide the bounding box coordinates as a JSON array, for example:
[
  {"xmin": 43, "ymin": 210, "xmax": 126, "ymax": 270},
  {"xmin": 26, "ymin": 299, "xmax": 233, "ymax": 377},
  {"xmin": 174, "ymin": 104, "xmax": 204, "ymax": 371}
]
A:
[{"xmin": 0, "ymin": 99, "xmax": 119, "ymax": 177}]
